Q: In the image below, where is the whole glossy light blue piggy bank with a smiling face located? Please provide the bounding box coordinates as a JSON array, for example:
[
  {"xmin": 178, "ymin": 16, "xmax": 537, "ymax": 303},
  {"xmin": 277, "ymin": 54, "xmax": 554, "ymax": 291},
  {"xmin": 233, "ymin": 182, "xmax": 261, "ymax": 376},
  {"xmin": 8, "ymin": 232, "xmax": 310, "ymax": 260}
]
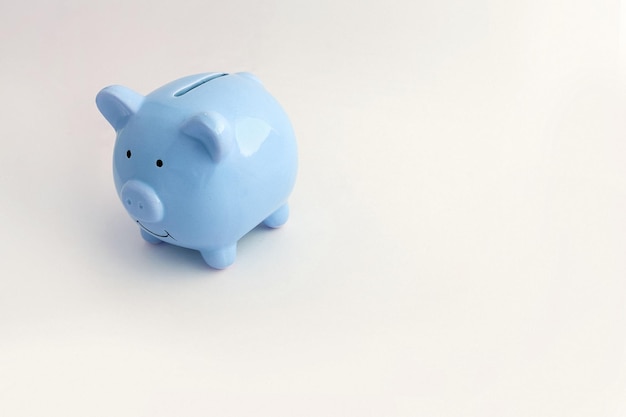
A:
[{"xmin": 96, "ymin": 73, "xmax": 298, "ymax": 269}]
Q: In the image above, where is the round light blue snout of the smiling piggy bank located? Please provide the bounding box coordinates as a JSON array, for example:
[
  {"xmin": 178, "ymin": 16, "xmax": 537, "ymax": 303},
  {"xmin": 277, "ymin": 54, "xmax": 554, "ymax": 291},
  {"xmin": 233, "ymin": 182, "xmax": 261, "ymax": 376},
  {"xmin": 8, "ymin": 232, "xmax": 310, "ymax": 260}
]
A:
[{"xmin": 121, "ymin": 180, "xmax": 163, "ymax": 223}]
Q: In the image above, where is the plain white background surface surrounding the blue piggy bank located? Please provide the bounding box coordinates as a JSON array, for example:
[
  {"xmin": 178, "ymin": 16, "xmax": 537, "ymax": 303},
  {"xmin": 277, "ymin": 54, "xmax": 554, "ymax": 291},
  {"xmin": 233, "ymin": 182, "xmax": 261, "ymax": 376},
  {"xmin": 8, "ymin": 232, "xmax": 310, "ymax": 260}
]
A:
[{"xmin": 0, "ymin": 0, "xmax": 626, "ymax": 417}]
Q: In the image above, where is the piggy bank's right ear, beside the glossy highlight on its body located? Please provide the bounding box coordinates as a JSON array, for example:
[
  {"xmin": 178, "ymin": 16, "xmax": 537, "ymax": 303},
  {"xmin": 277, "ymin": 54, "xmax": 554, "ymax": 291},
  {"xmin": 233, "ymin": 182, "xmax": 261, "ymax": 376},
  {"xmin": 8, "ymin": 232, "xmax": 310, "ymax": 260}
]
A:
[{"xmin": 181, "ymin": 112, "xmax": 234, "ymax": 162}]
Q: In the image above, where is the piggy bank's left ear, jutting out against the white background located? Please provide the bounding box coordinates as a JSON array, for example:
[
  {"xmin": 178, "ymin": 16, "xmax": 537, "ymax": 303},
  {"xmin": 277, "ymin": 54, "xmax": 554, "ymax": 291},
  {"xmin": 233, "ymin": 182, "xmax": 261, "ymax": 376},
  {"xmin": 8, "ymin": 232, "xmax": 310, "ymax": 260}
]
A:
[{"xmin": 96, "ymin": 85, "xmax": 144, "ymax": 130}]
